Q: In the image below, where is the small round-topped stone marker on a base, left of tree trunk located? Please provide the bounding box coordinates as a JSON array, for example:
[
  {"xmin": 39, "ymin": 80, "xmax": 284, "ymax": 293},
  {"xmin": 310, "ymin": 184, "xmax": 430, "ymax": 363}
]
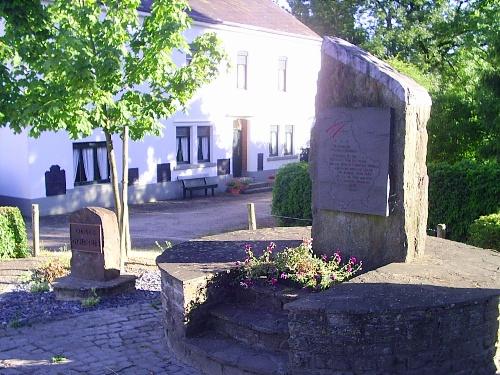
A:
[{"xmin": 54, "ymin": 207, "xmax": 135, "ymax": 300}]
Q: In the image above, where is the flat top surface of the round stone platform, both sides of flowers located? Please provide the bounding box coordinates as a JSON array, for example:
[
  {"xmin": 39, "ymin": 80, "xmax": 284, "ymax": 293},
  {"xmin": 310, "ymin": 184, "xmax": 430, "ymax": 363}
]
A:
[{"xmin": 156, "ymin": 227, "xmax": 500, "ymax": 312}]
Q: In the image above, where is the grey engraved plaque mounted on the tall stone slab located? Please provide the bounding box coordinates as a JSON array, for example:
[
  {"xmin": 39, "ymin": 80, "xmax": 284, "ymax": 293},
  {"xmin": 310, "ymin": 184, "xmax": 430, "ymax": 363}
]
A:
[{"xmin": 315, "ymin": 108, "xmax": 391, "ymax": 216}]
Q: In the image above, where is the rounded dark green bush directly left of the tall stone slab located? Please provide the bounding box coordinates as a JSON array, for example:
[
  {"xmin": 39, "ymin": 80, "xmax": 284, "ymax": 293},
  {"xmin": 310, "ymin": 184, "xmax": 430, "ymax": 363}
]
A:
[{"xmin": 272, "ymin": 163, "xmax": 312, "ymax": 226}]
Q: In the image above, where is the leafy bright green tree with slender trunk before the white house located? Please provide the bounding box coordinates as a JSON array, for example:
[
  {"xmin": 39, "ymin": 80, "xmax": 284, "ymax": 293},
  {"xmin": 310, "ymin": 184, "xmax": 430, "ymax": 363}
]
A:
[{"xmin": 0, "ymin": 0, "xmax": 224, "ymax": 267}]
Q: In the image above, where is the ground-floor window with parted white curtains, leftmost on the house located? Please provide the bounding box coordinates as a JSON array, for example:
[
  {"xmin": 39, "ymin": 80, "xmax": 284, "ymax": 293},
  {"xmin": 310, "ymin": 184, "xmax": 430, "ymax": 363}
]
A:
[{"xmin": 73, "ymin": 142, "xmax": 109, "ymax": 185}]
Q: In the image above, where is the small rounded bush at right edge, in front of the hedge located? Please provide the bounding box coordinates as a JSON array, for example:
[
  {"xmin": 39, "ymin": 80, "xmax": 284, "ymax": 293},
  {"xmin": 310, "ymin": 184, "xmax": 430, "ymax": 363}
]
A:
[{"xmin": 468, "ymin": 213, "xmax": 500, "ymax": 251}]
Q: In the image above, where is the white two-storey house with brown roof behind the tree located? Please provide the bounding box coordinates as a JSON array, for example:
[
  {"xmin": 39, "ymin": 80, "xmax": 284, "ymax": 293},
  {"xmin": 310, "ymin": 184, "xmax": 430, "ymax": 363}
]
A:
[{"xmin": 0, "ymin": 0, "xmax": 321, "ymax": 215}]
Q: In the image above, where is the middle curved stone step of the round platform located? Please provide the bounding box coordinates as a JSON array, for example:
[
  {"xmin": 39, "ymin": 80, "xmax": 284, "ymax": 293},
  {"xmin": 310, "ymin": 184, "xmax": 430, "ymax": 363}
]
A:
[{"xmin": 210, "ymin": 304, "xmax": 288, "ymax": 351}]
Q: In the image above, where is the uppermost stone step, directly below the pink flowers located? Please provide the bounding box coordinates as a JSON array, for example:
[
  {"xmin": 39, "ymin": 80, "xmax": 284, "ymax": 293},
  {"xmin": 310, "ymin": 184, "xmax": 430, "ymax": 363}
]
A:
[{"xmin": 236, "ymin": 285, "xmax": 310, "ymax": 311}]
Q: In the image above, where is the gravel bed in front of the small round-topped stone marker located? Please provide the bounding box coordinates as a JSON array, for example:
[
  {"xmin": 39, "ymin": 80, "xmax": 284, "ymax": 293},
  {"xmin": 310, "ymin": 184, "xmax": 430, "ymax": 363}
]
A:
[{"xmin": 0, "ymin": 269, "xmax": 161, "ymax": 329}]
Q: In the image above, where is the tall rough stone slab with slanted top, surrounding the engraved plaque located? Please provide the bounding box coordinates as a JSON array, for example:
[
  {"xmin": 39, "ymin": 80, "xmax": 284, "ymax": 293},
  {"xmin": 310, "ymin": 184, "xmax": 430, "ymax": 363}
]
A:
[{"xmin": 310, "ymin": 37, "xmax": 431, "ymax": 269}]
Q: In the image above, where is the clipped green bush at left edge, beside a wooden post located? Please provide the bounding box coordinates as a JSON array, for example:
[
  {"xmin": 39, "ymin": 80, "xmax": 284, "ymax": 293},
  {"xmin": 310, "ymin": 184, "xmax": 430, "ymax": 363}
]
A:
[{"xmin": 0, "ymin": 207, "xmax": 29, "ymax": 259}]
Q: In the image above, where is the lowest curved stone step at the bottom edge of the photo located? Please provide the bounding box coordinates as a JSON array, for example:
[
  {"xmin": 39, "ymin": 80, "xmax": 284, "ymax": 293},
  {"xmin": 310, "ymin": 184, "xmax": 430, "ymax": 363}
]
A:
[{"xmin": 186, "ymin": 331, "xmax": 288, "ymax": 375}]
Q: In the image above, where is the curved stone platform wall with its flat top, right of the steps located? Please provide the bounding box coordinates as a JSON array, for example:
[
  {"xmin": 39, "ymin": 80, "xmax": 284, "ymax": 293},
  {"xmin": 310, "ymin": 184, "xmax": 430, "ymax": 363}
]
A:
[{"xmin": 286, "ymin": 237, "xmax": 500, "ymax": 375}]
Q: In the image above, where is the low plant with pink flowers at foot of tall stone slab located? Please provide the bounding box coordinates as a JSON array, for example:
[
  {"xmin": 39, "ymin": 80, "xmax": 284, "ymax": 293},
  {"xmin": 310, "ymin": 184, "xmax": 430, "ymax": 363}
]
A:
[{"xmin": 237, "ymin": 240, "xmax": 362, "ymax": 290}]
